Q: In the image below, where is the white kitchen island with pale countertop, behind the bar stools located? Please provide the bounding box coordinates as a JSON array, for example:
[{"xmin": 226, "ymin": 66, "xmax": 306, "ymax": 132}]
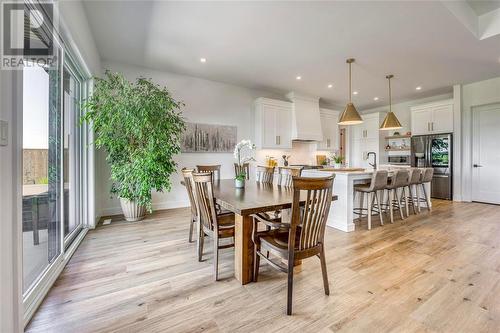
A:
[{"xmin": 301, "ymin": 167, "xmax": 431, "ymax": 232}]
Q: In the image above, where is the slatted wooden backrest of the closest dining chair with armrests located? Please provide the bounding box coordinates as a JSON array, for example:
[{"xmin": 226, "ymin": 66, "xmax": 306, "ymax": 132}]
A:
[{"xmin": 288, "ymin": 175, "xmax": 335, "ymax": 251}]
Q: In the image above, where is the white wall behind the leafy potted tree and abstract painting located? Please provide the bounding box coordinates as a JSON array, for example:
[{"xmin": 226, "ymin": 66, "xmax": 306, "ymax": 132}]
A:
[{"xmin": 96, "ymin": 63, "xmax": 277, "ymax": 215}]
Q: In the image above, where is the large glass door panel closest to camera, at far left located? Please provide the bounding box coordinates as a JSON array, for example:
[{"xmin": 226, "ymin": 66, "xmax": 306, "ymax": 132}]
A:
[{"xmin": 22, "ymin": 50, "xmax": 62, "ymax": 293}]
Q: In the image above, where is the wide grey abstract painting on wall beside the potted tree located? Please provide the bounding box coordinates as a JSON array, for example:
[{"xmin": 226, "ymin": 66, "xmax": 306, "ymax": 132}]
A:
[{"xmin": 181, "ymin": 123, "xmax": 236, "ymax": 153}]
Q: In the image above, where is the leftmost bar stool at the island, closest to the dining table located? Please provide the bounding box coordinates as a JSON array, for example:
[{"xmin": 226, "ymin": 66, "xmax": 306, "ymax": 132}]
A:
[{"xmin": 354, "ymin": 170, "xmax": 387, "ymax": 230}]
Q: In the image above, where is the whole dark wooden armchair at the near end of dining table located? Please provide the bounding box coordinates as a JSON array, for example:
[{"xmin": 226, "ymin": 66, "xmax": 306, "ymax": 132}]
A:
[{"xmin": 252, "ymin": 175, "xmax": 335, "ymax": 315}]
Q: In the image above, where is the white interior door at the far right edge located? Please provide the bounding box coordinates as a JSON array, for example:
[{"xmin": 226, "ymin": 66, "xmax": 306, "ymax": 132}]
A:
[{"xmin": 472, "ymin": 104, "xmax": 500, "ymax": 204}]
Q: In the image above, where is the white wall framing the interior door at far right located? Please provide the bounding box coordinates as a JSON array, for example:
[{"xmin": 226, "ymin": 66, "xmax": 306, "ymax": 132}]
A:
[{"xmin": 462, "ymin": 77, "xmax": 500, "ymax": 201}]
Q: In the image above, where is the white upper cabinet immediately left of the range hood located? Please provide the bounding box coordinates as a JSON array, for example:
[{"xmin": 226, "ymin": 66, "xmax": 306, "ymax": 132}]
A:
[{"xmin": 254, "ymin": 98, "xmax": 292, "ymax": 149}]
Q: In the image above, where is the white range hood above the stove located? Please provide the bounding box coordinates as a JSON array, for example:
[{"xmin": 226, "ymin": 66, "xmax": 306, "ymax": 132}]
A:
[{"xmin": 286, "ymin": 91, "xmax": 323, "ymax": 141}]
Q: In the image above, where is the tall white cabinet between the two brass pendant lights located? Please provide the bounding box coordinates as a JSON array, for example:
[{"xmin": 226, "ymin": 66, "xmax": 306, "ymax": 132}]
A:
[{"xmin": 348, "ymin": 112, "xmax": 386, "ymax": 168}]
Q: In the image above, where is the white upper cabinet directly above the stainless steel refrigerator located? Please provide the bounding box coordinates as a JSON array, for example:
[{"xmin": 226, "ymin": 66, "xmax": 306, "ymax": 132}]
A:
[{"xmin": 411, "ymin": 100, "xmax": 453, "ymax": 135}]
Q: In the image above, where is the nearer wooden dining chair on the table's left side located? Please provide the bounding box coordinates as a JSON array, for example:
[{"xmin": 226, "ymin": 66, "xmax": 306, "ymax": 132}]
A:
[{"xmin": 193, "ymin": 172, "xmax": 234, "ymax": 281}]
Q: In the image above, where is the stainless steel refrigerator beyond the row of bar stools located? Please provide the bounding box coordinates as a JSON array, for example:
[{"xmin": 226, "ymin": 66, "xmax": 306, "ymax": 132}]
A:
[{"xmin": 411, "ymin": 134, "xmax": 453, "ymax": 200}]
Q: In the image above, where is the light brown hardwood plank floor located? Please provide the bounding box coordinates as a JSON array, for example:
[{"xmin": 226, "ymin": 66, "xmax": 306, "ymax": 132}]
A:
[{"xmin": 27, "ymin": 201, "xmax": 500, "ymax": 333}]
